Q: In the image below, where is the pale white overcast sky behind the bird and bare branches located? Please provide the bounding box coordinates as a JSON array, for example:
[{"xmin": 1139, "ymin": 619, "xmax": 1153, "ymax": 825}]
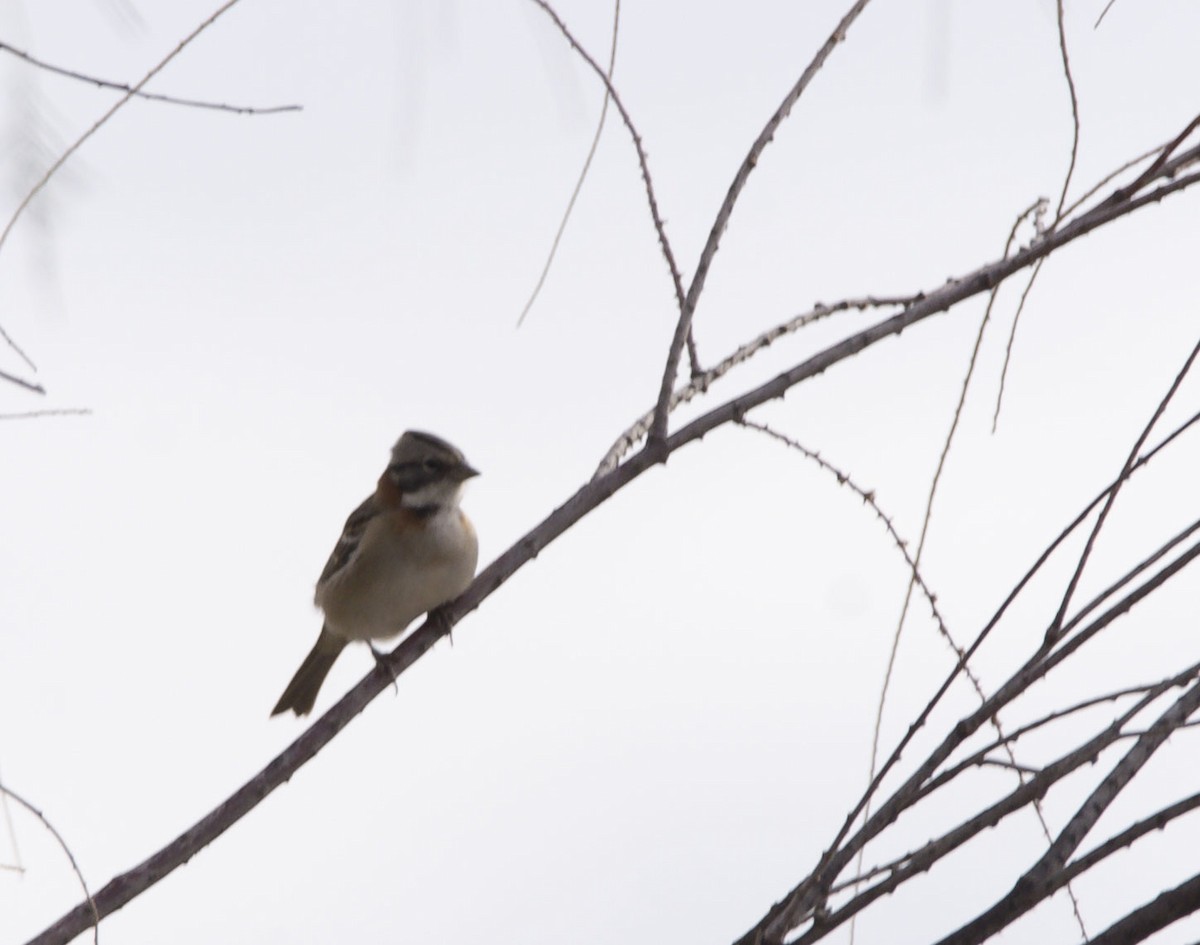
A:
[{"xmin": 0, "ymin": 0, "xmax": 1200, "ymax": 945}]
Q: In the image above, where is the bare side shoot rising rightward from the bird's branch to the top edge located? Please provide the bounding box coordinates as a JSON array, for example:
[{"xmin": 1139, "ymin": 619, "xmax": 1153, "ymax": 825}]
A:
[{"xmin": 647, "ymin": 0, "xmax": 869, "ymax": 449}]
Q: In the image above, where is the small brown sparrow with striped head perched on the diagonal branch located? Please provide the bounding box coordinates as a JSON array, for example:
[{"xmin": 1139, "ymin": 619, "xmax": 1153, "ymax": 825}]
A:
[{"xmin": 271, "ymin": 431, "xmax": 479, "ymax": 716}]
